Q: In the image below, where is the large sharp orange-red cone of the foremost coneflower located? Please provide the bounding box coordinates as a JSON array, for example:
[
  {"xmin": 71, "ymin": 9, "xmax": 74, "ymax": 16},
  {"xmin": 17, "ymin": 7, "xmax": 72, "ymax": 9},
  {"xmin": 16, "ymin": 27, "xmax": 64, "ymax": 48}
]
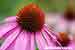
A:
[{"xmin": 17, "ymin": 3, "xmax": 44, "ymax": 32}]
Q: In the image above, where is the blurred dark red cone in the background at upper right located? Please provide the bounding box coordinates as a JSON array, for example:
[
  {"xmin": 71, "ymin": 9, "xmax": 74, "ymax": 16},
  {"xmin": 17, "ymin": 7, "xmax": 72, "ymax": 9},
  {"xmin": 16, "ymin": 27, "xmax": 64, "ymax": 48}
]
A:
[{"xmin": 64, "ymin": 6, "xmax": 75, "ymax": 21}]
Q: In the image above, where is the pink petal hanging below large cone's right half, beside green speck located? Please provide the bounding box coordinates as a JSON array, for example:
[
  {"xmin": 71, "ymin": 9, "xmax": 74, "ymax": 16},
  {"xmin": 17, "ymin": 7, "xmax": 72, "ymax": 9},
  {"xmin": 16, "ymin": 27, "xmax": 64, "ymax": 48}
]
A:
[{"xmin": 36, "ymin": 32, "xmax": 47, "ymax": 50}]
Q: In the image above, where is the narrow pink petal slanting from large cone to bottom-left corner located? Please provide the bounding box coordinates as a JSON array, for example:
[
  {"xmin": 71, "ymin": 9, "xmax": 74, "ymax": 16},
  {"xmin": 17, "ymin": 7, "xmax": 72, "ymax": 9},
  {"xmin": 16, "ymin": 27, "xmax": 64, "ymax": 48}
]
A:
[{"xmin": 0, "ymin": 28, "xmax": 20, "ymax": 50}]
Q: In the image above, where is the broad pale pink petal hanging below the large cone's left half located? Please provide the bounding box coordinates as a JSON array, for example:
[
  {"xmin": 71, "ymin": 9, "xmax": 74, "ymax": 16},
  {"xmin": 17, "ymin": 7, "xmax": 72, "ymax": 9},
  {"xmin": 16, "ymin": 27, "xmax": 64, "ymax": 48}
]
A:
[{"xmin": 14, "ymin": 32, "xmax": 31, "ymax": 50}]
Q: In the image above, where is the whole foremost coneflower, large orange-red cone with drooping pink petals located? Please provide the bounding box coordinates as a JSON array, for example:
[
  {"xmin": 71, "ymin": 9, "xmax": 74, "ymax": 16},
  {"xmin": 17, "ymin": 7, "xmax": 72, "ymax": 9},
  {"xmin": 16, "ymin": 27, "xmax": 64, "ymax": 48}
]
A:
[{"xmin": 0, "ymin": 4, "xmax": 59, "ymax": 50}]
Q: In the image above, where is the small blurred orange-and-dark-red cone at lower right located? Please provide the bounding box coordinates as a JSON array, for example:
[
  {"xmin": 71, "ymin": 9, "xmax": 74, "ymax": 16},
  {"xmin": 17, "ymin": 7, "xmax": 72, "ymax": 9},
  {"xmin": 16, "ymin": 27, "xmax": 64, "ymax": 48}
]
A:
[{"xmin": 57, "ymin": 32, "xmax": 71, "ymax": 47}]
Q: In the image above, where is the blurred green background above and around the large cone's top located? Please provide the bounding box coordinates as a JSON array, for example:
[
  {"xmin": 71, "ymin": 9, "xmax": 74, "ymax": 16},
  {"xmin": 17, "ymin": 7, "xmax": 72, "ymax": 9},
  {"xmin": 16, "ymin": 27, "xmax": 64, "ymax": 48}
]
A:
[{"xmin": 0, "ymin": 0, "xmax": 68, "ymax": 20}]
